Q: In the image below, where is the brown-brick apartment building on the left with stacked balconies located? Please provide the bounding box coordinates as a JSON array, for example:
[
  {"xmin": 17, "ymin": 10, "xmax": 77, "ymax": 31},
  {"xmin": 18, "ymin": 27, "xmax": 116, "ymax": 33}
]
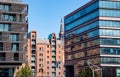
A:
[{"xmin": 0, "ymin": 0, "xmax": 28, "ymax": 77}]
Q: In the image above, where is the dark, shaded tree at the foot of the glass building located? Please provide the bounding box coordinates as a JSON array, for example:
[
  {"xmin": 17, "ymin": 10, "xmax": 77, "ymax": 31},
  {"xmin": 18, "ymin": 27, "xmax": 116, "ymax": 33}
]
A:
[{"xmin": 78, "ymin": 68, "xmax": 97, "ymax": 77}]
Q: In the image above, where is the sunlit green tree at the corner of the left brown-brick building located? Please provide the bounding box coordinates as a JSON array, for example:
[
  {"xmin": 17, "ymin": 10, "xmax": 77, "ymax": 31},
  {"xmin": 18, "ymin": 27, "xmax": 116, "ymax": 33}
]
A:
[{"xmin": 16, "ymin": 64, "xmax": 32, "ymax": 77}]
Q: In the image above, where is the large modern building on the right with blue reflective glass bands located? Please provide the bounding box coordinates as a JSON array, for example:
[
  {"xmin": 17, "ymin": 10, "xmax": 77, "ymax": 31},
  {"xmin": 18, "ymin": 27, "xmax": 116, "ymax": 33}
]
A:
[{"xmin": 64, "ymin": 0, "xmax": 120, "ymax": 77}]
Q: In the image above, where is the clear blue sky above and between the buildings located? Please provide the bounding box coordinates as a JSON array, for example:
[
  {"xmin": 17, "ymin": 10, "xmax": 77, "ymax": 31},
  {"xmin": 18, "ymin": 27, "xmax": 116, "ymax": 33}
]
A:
[{"xmin": 23, "ymin": 0, "xmax": 90, "ymax": 39}]
